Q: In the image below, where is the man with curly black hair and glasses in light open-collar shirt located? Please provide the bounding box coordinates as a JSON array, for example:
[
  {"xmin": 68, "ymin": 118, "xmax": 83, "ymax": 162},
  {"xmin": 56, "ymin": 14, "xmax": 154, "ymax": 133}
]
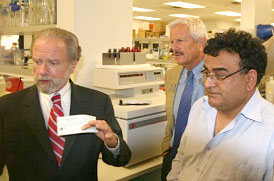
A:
[{"xmin": 167, "ymin": 30, "xmax": 274, "ymax": 181}]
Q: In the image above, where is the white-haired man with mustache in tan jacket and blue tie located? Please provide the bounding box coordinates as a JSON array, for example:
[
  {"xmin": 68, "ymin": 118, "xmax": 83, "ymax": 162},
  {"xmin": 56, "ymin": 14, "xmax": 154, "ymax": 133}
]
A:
[{"xmin": 161, "ymin": 18, "xmax": 207, "ymax": 181}]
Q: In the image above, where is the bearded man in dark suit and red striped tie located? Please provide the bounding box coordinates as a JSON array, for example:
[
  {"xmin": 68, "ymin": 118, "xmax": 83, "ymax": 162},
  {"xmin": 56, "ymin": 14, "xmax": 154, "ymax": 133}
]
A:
[{"xmin": 0, "ymin": 28, "xmax": 131, "ymax": 181}]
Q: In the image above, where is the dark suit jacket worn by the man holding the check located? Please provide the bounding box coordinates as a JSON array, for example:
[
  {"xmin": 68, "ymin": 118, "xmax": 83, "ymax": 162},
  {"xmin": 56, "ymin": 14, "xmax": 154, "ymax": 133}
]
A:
[{"xmin": 0, "ymin": 82, "xmax": 131, "ymax": 181}]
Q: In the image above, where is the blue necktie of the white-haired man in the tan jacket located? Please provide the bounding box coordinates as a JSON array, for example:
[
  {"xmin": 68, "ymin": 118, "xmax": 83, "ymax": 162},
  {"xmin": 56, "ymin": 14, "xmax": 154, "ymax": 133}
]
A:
[{"xmin": 171, "ymin": 70, "xmax": 194, "ymax": 159}]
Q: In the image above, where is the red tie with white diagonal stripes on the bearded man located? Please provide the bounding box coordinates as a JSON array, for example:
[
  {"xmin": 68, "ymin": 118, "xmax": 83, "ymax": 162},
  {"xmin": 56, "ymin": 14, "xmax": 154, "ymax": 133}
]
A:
[{"xmin": 48, "ymin": 93, "xmax": 65, "ymax": 166}]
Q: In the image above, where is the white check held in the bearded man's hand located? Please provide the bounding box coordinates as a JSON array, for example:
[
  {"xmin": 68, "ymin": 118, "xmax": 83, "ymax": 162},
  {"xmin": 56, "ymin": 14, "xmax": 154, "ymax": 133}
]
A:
[{"xmin": 57, "ymin": 114, "xmax": 98, "ymax": 136}]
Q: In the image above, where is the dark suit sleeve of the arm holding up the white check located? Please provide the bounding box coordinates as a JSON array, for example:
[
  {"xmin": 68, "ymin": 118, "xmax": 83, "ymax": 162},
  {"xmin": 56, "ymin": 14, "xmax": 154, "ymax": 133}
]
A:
[{"xmin": 102, "ymin": 96, "xmax": 131, "ymax": 166}]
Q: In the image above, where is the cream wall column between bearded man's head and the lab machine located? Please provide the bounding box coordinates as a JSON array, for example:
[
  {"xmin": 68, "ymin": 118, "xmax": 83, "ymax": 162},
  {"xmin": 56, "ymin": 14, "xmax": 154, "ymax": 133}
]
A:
[{"xmin": 57, "ymin": 0, "xmax": 133, "ymax": 87}]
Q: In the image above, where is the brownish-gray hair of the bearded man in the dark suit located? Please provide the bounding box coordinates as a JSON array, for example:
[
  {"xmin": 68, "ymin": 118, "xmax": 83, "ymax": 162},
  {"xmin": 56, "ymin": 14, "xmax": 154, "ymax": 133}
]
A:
[{"xmin": 31, "ymin": 28, "xmax": 81, "ymax": 61}]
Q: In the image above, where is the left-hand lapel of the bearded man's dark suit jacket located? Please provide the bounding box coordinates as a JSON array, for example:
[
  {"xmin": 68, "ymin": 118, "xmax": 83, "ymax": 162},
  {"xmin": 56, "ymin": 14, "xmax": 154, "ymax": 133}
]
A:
[{"xmin": 22, "ymin": 85, "xmax": 56, "ymax": 160}]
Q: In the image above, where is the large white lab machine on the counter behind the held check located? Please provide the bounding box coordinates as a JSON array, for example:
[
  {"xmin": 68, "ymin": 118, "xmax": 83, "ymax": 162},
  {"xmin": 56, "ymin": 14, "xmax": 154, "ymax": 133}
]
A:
[{"xmin": 93, "ymin": 64, "xmax": 166, "ymax": 166}]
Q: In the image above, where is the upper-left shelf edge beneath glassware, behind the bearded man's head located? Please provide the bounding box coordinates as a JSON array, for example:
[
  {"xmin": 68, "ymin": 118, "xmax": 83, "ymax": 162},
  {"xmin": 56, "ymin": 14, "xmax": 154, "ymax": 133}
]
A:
[{"xmin": 0, "ymin": 24, "xmax": 56, "ymax": 35}]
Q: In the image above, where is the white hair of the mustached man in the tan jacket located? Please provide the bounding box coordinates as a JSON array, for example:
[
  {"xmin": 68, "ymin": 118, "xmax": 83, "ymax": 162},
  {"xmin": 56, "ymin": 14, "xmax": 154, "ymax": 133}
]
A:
[{"xmin": 168, "ymin": 17, "xmax": 208, "ymax": 41}]
